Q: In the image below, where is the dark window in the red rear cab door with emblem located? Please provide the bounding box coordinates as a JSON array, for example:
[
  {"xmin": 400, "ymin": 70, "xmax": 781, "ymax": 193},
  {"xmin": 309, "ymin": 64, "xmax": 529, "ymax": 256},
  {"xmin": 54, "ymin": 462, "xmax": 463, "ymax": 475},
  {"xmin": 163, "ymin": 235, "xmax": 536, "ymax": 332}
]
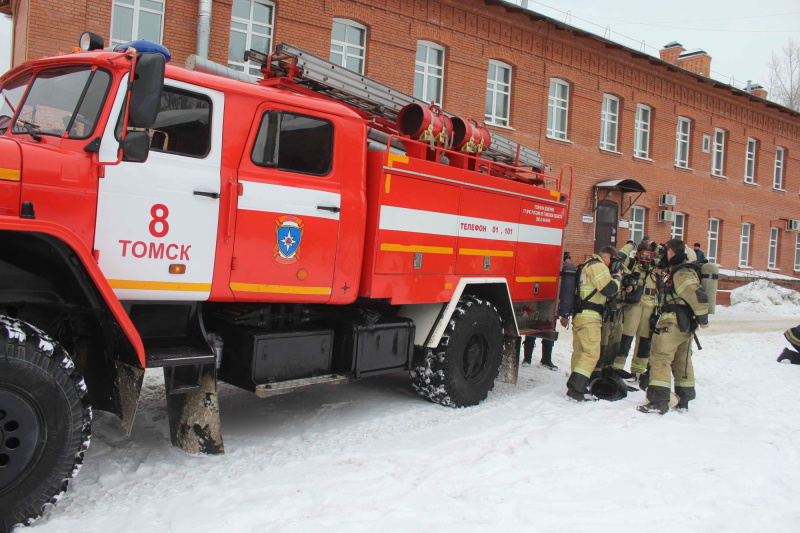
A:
[{"xmin": 251, "ymin": 111, "xmax": 333, "ymax": 176}]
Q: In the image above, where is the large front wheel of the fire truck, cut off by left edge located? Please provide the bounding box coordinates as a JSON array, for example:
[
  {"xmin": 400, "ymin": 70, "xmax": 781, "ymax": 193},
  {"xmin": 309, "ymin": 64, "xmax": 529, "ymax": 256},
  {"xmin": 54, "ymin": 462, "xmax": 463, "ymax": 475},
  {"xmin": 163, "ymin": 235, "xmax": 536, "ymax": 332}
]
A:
[{"xmin": 0, "ymin": 316, "xmax": 92, "ymax": 532}]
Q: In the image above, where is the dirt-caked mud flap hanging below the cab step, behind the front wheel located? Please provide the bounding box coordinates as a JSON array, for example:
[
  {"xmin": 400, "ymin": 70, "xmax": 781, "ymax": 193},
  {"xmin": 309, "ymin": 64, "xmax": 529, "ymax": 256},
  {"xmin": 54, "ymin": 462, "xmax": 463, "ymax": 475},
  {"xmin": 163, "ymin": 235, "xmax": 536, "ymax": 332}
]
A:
[{"xmin": 165, "ymin": 363, "xmax": 225, "ymax": 455}]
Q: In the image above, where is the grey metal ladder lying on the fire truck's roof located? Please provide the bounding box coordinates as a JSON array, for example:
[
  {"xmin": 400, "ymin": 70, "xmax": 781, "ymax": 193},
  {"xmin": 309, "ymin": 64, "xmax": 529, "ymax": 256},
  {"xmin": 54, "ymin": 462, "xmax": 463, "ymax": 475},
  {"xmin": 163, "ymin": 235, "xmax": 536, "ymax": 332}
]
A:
[{"xmin": 252, "ymin": 43, "xmax": 545, "ymax": 172}]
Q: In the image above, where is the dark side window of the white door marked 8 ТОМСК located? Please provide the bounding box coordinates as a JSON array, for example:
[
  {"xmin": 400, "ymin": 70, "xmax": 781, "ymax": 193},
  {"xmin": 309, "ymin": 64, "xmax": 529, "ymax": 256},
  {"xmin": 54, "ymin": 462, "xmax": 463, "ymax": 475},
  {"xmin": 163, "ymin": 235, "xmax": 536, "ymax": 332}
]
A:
[{"xmin": 150, "ymin": 87, "xmax": 211, "ymax": 157}]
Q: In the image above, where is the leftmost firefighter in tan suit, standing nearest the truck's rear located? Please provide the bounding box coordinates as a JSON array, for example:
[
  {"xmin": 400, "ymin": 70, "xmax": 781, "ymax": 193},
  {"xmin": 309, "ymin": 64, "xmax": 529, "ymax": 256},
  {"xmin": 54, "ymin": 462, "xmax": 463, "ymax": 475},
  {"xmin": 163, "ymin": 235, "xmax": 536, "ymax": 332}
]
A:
[{"xmin": 567, "ymin": 245, "xmax": 622, "ymax": 402}]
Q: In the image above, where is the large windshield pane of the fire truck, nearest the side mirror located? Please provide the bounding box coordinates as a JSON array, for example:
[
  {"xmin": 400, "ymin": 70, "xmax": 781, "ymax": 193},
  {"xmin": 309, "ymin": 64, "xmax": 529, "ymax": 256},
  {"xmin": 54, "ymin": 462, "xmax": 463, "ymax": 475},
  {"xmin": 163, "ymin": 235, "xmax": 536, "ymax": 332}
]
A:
[{"xmin": 11, "ymin": 67, "xmax": 111, "ymax": 139}]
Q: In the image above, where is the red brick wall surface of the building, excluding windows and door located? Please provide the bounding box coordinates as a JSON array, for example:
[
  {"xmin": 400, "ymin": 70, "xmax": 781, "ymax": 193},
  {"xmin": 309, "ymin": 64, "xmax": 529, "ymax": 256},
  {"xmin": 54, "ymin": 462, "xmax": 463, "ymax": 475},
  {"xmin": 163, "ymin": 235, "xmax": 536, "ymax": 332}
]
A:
[{"xmin": 12, "ymin": 0, "xmax": 800, "ymax": 275}]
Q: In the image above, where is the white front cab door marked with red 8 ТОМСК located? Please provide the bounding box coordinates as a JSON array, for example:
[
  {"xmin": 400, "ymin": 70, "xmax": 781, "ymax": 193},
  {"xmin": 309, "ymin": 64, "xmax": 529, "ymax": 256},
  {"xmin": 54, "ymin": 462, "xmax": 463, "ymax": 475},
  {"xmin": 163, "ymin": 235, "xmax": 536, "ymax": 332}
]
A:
[{"xmin": 95, "ymin": 80, "xmax": 225, "ymax": 300}]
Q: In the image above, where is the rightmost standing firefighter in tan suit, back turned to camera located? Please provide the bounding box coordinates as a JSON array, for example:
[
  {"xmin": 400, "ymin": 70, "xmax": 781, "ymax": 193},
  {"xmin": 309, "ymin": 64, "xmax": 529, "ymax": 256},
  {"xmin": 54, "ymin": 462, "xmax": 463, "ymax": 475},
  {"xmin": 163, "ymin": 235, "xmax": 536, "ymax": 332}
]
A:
[{"xmin": 638, "ymin": 239, "xmax": 708, "ymax": 415}]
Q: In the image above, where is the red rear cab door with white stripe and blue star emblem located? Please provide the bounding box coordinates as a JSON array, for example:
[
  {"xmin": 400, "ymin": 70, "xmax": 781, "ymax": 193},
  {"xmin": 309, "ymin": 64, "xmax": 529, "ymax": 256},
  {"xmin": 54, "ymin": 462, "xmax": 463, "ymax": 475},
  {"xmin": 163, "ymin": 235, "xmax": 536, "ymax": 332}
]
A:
[{"xmin": 230, "ymin": 104, "xmax": 342, "ymax": 303}]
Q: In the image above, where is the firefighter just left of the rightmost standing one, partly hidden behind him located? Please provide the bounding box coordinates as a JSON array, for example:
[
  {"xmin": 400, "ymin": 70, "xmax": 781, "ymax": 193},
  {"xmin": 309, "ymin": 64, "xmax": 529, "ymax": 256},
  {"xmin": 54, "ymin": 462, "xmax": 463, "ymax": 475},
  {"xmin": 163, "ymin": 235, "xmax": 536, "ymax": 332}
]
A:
[{"xmin": 614, "ymin": 241, "xmax": 658, "ymax": 381}]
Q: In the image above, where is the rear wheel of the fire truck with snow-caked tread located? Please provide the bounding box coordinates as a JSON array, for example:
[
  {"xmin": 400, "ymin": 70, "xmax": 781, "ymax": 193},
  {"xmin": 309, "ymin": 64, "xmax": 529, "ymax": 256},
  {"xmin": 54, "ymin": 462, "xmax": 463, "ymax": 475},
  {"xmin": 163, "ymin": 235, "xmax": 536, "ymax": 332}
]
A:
[{"xmin": 410, "ymin": 295, "xmax": 503, "ymax": 407}]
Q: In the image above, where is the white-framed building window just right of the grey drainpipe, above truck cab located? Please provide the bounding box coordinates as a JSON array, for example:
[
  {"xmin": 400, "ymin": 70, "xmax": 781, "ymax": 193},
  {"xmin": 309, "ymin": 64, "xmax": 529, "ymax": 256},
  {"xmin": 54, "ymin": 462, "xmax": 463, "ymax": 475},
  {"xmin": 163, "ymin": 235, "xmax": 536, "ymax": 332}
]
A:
[{"xmin": 228, "ymin": 0, "xmax": 275, "ymax": 77}]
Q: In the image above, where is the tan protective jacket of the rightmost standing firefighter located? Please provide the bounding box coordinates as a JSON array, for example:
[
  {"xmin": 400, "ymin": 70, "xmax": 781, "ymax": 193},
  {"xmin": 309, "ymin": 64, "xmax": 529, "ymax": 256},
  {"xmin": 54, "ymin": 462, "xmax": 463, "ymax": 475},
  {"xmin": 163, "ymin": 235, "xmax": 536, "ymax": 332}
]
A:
[{"xmin": 656, "ymin": 254, "xmax": 708, "ymax": 333}]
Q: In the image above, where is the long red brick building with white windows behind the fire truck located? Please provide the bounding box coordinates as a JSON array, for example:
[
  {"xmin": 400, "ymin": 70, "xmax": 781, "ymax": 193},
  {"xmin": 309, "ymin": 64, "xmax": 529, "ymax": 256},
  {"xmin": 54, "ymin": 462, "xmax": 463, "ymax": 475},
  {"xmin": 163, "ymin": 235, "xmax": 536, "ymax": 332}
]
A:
[{"xmin": 0, "ymin": 0, "xmax": 800, "ymax": 276}]
